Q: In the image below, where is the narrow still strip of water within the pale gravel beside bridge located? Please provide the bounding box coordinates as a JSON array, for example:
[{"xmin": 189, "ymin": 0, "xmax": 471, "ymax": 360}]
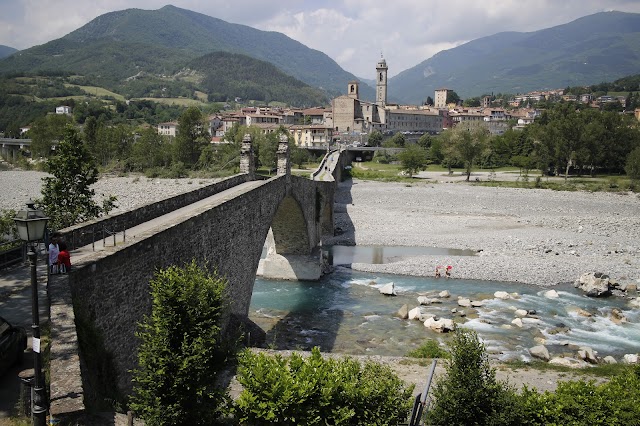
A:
[{"xmin": 324, "ymin": 246, "xmax": 477, "ymax": 265}]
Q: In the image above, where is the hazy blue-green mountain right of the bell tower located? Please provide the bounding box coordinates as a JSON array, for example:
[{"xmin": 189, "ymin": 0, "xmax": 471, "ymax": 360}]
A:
[{"xmin": 389, "ymin": 12, "xmax": 640, "ymax": 103}]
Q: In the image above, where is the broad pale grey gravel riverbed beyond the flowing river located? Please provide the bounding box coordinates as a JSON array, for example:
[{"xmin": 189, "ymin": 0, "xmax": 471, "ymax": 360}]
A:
[{"xmin": 326, "ymin": 176, "xmax": 640, "ymax": 286}]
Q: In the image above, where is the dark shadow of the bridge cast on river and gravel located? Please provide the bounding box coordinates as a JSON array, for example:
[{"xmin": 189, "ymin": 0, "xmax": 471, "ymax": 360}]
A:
[{"xmin": 252, "ymin": 177, "xmax": 357, "ymax": 352}]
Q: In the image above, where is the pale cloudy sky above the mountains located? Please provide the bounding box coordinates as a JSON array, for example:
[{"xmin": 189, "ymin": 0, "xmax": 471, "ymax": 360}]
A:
[{"xmin": 0, "ymin": 0, "xmax": 640, "ymax": 79}]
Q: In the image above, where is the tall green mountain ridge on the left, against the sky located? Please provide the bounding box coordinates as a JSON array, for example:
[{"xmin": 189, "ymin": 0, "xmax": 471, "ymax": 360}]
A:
[{"xmin": 0, "ymin": 6, "xmax": 374, "ymax": 98}]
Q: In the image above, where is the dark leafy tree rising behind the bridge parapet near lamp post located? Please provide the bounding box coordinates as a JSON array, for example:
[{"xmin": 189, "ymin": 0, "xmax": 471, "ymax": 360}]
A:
[{"xmin": 37, "ymin": 125, "xmax": 116, "ymax": 229}]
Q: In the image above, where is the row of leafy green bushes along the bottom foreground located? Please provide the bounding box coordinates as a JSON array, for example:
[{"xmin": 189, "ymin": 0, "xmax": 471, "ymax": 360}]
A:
[{"xmin": 131, "ymin": 262, "xmax": 640, "ymax": 426}]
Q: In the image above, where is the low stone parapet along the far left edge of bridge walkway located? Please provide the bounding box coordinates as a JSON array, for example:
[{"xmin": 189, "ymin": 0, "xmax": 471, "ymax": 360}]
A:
[{"xmin": 60, "ymin": 174, "xmax": 249, "ymax": 249}]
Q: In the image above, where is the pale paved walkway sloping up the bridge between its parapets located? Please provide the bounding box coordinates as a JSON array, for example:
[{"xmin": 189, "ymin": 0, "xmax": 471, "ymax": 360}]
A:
[{"xmin": 70, "ymin": 180, "xmax": 268, "ymax": 266}]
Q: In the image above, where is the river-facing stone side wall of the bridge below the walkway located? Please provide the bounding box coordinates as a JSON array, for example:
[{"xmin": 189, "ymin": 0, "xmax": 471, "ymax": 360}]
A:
[{"xmin": 57, "ymin": 176, "xmax": 334, "ymax": 400}]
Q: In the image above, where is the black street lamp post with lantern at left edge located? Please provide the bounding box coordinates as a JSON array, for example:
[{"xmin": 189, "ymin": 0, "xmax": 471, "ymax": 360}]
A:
[{"xmin": 14, "ymin": 200, "xmax": 49, "ymax": 426}]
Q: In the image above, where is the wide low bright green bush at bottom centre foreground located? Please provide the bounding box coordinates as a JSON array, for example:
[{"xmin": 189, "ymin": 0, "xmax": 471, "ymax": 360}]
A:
[{"xmin": 236, "ymin": 348, "xmax": 413, "ymax": 426}]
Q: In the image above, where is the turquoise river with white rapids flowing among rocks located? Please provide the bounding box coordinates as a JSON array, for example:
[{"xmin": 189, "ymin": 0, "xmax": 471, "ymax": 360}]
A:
[{"xmin": 249, "ymin": 268, "xmax": 640, "ymax": 360}]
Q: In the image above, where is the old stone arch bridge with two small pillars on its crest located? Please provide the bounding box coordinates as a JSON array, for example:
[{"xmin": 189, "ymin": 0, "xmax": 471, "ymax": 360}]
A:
[{"xmin": 49, "ymin": 135, "xmax": 349, "ymax": 416}]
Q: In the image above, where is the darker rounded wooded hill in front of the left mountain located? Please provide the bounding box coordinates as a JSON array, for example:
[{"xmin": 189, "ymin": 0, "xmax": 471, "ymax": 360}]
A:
[{"xmin": 188, "ymin": 52, "xmax": 329, "ymax": 106}]
